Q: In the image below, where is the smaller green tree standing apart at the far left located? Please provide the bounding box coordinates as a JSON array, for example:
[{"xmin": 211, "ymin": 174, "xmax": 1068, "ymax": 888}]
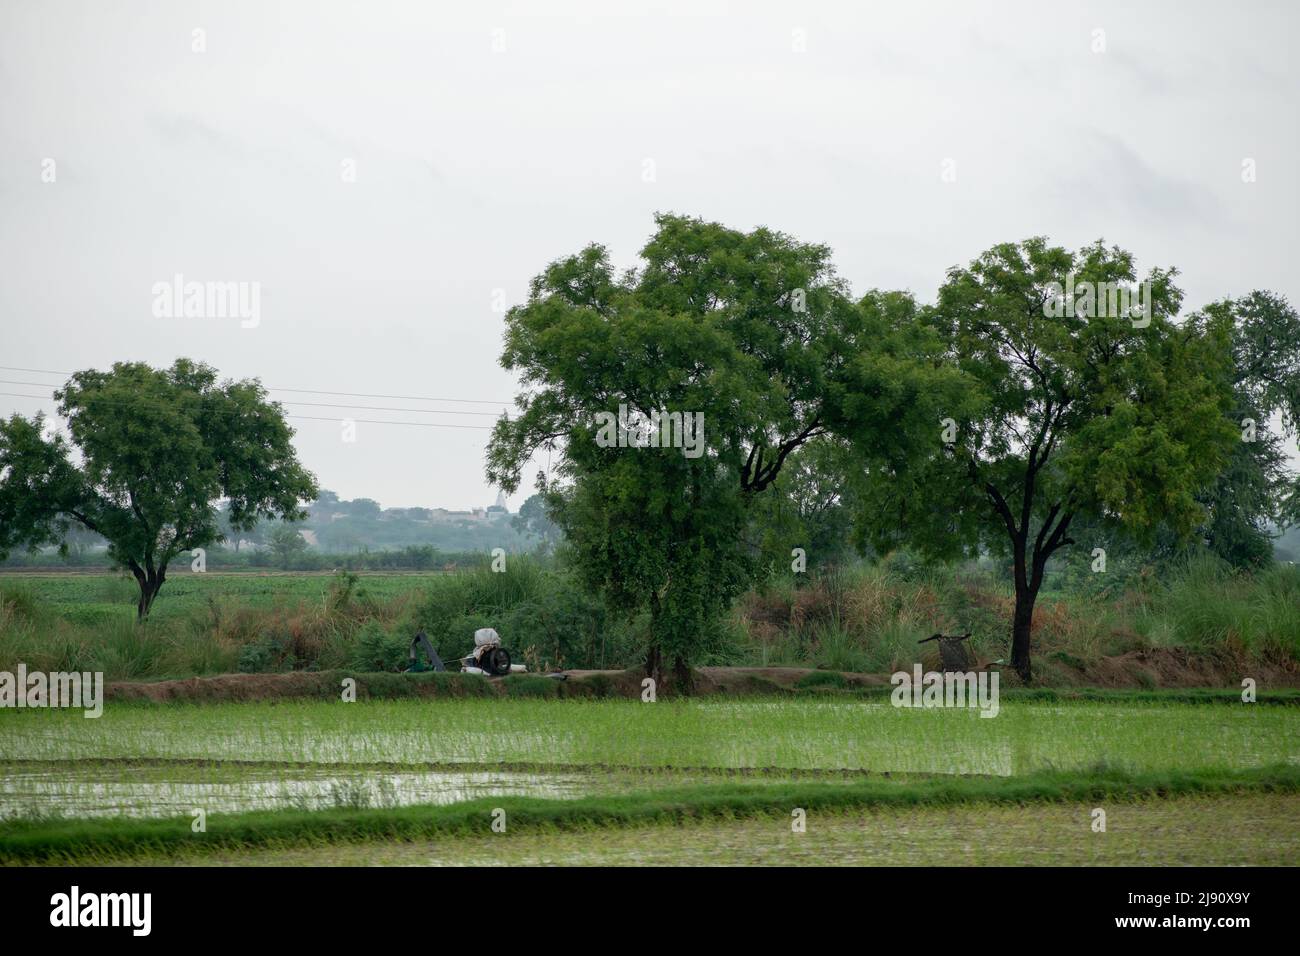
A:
[{"xmin": 0, "ymin": 359, "xmax": 316, "ymax": 618}]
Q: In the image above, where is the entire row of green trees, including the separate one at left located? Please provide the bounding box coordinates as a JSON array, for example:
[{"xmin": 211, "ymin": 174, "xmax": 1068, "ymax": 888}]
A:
[{"xmin": 0, "ymin": 215, "xmax": 1300, "ymax": 683}]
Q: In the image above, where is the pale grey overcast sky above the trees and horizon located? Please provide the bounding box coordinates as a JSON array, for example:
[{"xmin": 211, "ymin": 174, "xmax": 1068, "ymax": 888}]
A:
[{"xmin": 0, "ymin": 0, "xmax": 1300, "ymax": 510}]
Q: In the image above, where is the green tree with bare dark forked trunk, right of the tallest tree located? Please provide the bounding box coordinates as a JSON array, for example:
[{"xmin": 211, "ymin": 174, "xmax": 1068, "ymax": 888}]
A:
[{"xmin": 863, "ymin": 239, "xmax": 1239, "ymax": 680}]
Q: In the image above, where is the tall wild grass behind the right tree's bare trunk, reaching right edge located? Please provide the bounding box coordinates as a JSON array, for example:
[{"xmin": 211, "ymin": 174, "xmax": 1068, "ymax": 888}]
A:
[{"xmin": 736, "ymin": 554, "xmax": 1300, "ymax": 683}]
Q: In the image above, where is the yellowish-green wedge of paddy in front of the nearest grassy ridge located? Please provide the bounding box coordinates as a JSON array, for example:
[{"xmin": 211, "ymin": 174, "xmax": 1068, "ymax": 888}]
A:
[{"xmin": 185, "ymin": 793, "xmax": 1300, "ymax": 866}]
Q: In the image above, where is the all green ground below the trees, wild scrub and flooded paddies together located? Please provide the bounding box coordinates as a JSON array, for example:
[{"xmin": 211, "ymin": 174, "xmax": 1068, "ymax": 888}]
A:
[{"xmin": 0, "ymin": 561, "xmax": 1300, "ymax": 865}]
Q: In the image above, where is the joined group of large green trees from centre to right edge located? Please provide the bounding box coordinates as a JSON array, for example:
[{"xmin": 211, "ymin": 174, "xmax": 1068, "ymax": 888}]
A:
[{"xmin": 488, "ymin": 215, "xmax": 1300, "ymax": 682}]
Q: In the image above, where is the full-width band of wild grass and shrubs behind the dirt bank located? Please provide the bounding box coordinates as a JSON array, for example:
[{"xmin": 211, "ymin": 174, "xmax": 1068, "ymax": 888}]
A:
[{"xmin": 0, "ymin": 557, "xmax": 1300, "ymax": 687}]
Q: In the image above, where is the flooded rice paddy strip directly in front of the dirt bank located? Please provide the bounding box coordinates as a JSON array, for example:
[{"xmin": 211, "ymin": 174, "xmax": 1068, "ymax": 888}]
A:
[{"xmin": 0, "ymin": 697, "xmax": 1300, "ymax": 775}]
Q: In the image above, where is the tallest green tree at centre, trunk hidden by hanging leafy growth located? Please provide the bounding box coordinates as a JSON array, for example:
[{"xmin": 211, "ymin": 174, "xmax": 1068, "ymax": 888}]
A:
[{"xmin": 488, "ymin": 215, "xmax": 946, "ymax": 683}]
